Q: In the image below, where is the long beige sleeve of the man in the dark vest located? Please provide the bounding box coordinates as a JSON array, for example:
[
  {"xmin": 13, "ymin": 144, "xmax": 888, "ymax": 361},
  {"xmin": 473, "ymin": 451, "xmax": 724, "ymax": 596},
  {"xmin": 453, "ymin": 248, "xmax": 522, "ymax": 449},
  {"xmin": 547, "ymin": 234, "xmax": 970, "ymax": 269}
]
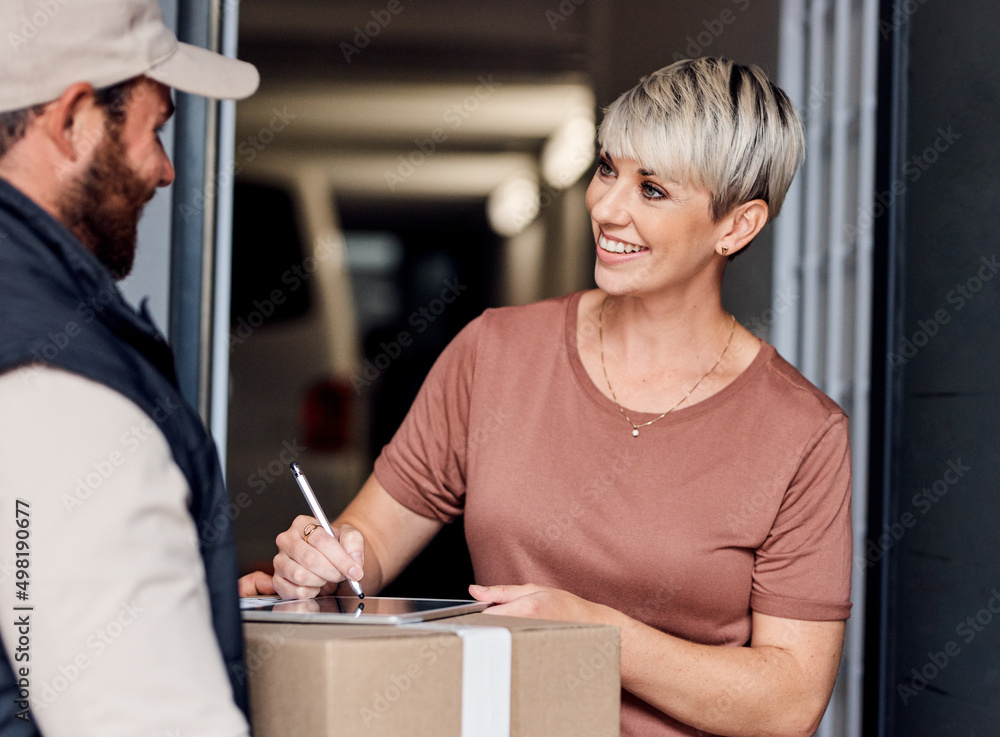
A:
[{"xmin": 0, "ymin": 366, "xmax": 248, "ymax": 737}]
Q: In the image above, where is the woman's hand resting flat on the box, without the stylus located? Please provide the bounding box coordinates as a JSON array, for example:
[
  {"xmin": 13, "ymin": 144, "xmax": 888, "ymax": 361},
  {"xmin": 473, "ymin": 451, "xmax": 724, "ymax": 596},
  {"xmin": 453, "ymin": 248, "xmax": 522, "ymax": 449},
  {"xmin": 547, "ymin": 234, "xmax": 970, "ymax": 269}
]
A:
[{"xmin": 469, "ymin": 584, "xmax": 625, "ymax": 625}]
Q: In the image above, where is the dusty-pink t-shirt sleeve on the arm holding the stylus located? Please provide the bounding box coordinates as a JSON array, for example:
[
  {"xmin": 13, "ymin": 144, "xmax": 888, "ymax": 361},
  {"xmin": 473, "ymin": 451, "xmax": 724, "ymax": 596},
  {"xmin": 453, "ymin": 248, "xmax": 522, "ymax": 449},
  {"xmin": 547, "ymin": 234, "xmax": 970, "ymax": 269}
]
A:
[{"xmin": 375, "ymin": 316, "xmax": 485, "ymax": 522}]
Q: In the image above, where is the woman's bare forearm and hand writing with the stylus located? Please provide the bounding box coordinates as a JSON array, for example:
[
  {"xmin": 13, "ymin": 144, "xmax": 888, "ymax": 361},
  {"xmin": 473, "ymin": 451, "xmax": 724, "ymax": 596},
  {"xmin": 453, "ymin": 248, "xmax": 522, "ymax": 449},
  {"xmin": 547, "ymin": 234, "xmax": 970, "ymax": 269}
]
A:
[{"xmin": 272, "ymin": 474, "xmax": 444, "ymax": 599}]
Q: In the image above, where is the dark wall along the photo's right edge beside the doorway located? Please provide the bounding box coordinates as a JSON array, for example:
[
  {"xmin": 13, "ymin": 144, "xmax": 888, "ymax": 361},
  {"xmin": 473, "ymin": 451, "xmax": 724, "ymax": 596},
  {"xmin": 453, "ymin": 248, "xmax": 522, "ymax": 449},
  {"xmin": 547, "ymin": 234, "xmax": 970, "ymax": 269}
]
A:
[{"xmin": 880, "ymin": 0, "xmax": 1000, "ymax": 737}]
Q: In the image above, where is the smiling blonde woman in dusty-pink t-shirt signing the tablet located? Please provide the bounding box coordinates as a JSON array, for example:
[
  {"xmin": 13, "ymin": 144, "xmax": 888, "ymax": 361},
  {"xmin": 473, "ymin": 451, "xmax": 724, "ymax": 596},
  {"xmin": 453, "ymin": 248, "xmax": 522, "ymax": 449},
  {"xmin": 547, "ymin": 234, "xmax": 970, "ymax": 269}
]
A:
[{"xmin": 262, "ymin": 58, "xmax": 851, "ymax": 736}]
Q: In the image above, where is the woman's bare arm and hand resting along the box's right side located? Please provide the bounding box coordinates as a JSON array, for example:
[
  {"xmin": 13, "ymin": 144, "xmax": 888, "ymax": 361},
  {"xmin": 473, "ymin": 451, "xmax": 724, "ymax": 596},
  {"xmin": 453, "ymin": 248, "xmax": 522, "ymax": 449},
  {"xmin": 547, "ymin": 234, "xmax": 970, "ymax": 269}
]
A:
[{"xmin": 469, "ymin": 585, "xmax": 844, "ymax": 737}]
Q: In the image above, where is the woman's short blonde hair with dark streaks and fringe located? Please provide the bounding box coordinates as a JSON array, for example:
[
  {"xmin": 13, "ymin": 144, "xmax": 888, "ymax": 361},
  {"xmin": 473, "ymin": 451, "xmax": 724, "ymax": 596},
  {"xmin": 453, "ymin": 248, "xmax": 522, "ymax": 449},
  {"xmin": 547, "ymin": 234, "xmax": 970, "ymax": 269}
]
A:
[{"xmin": 598, "ymin": 57, "xmax": 805, "ymax": 220}]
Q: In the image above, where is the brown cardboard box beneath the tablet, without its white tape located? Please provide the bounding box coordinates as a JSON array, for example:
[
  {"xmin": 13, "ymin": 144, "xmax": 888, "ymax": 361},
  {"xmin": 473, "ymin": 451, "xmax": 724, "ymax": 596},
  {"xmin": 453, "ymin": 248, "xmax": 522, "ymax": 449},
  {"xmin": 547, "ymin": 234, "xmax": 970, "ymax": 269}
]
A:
[{"xmin": 244, "ymin": 614, "xmax": 621, "ymax": 737}]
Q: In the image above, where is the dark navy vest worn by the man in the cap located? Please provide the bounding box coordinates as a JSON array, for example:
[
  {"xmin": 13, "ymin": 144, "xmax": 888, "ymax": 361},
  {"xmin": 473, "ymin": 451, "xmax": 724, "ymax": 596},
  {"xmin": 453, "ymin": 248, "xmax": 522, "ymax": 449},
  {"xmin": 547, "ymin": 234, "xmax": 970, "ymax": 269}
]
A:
[{"xmin": 0, "ymin": 179, "xmax": 247, "ymax": 737}]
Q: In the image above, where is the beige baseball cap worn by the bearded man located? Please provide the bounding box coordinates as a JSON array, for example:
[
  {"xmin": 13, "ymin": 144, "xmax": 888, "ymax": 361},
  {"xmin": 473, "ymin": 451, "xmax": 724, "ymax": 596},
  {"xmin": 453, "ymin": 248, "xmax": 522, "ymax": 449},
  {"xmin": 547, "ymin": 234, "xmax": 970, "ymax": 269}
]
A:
[{"xmin": 0, "ymin": 0, "xmax": 260, "ymax": 112}]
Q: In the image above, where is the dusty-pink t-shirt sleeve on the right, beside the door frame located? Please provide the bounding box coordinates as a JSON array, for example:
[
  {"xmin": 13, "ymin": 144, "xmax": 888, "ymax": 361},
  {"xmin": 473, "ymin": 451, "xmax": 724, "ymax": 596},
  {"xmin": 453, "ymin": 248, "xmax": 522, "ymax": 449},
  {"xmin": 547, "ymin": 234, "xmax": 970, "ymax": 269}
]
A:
[{"xmin": 750, "ymin": 412, "xmax": 852, "ymax": 621}]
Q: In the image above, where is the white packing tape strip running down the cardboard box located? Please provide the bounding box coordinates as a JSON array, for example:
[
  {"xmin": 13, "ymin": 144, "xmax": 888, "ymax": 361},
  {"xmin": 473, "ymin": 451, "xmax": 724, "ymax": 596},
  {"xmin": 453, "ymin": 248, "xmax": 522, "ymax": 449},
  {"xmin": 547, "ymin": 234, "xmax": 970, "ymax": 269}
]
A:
[{"xmin": 404, "ymin": 622, "xmax": 511, "ymax": 737}]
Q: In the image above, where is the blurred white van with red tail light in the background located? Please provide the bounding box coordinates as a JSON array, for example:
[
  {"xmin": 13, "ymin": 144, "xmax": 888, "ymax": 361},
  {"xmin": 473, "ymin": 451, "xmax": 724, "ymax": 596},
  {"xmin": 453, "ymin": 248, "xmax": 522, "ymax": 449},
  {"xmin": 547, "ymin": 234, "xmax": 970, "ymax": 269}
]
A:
[{"xmin": 226, "ymin": 167, "xmax": 370, "ymax": 569}]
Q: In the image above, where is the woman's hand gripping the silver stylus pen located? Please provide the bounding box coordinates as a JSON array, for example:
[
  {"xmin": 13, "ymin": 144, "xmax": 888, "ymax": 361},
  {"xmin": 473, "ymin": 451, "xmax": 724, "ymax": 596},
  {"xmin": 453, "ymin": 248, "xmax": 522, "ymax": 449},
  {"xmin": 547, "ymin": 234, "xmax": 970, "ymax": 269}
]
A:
[{"xmin": 272, "ymin": 516, "xmax": 365, "ymax": 599}]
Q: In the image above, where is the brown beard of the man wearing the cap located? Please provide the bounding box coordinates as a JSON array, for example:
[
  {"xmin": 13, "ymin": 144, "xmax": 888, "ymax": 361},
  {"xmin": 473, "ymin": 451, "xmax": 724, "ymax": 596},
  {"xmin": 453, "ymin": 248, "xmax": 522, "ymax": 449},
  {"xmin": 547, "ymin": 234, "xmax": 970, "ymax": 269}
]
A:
[{"xmin": 60, "ymin": 125, "xmax": 156, "ymax": 280}]
